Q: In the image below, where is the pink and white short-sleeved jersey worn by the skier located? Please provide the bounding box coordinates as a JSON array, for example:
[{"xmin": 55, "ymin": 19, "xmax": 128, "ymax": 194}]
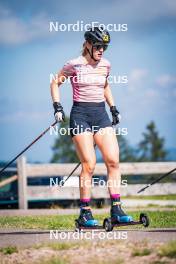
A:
[{"xmin": 62, "ymin": 56, "xmax": 110, "ymax": 103}]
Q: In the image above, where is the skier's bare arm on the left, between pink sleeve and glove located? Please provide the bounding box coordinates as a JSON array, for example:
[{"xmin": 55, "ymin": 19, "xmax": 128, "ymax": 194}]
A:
[{"xmin": 50, "ymin": 71, "xmax": 67, "ymax": 103}]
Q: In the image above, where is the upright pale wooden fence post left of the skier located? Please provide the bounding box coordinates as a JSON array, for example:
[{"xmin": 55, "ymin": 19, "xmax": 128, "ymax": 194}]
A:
[{"xmin": 17, "ymin": 156, "xmax": 28, "ymax": 209}]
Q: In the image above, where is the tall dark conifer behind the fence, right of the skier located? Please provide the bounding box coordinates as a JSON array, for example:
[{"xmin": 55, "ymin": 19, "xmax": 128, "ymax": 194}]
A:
[{"xmin": 138, "ymin": 121, "xmax": 167, "ymax": 161}]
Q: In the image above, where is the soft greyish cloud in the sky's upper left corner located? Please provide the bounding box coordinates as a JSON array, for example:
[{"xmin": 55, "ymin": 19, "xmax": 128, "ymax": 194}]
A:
[{"xmin": 0, "ymin": 6, "xmax": 49, "ymax": 44}]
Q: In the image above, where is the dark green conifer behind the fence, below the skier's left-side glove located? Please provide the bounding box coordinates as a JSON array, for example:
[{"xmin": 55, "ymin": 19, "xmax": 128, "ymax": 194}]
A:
[{"xmin": 51, "ymin": 117, "xmax": 79, "ymax": 163}]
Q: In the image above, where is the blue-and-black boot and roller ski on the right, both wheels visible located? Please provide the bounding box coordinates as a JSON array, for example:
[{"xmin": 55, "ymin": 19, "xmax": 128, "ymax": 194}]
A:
[{"xmin": 103, "ymin": 202, "xmax": 149, "ymax": 232}]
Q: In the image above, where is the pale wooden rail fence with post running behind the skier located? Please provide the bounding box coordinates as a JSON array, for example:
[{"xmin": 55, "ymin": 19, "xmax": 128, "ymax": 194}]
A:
[{"xmin": 0, "ymin": 156, "xmax": 176, "ymax": 209}]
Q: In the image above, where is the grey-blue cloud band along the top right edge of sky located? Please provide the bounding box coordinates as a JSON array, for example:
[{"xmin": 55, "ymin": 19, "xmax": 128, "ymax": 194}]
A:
[{"xmin": 87, "ymin": 0, "xmax": 176, "ymax": 26}]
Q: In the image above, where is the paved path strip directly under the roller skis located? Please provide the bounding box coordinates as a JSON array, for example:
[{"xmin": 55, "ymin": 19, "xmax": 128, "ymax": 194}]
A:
[{"xmin": 0, "ymin": 228, "xmax": 176, "ymax": 247}]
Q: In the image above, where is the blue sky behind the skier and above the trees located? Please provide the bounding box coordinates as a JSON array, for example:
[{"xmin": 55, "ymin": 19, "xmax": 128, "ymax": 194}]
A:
[{"xmin": 0, "ymin": 0, "xmax": 176, "ymax": 162}]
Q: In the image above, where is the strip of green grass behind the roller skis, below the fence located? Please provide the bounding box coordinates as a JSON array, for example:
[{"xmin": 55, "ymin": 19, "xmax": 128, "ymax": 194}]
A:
[{"xmin": 0, "ymin": 210, "xmax": 176, "ymax": 230}]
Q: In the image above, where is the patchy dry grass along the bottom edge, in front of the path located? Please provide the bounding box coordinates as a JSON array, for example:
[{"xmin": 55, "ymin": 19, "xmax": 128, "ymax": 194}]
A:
[{"xmin": 0, "ymin": 240, "xmax": 176, "ymax": 264}]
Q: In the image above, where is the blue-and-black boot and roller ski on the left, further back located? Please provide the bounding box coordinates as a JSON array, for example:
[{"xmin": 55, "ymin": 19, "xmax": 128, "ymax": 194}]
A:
[{"xmin": 75, "ymin": 208, "xmax": 103, "ymax": 231}]
